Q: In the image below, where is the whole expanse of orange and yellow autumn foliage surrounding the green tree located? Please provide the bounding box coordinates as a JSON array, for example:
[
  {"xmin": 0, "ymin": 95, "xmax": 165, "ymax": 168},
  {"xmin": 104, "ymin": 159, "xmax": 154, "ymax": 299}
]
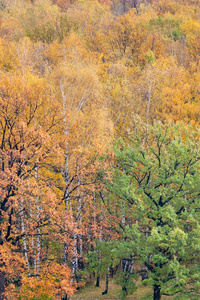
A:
[{"xmin": 0, "ymin": 0, "xmax": 200, "ymax": 299}]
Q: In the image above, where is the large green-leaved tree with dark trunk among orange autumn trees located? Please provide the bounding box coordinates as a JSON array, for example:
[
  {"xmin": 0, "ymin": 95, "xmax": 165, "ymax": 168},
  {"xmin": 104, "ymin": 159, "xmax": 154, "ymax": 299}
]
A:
[{"xmin": 101, "ymin": 124, "xmax": 200, "ymax": 300}]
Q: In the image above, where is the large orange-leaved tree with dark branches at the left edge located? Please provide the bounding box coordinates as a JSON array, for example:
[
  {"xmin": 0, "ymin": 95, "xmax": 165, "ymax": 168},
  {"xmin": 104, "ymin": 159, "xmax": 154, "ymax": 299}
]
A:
[{"xmin": 0, "ymin": 73, "xmax": 66, "ymax": 297}]
